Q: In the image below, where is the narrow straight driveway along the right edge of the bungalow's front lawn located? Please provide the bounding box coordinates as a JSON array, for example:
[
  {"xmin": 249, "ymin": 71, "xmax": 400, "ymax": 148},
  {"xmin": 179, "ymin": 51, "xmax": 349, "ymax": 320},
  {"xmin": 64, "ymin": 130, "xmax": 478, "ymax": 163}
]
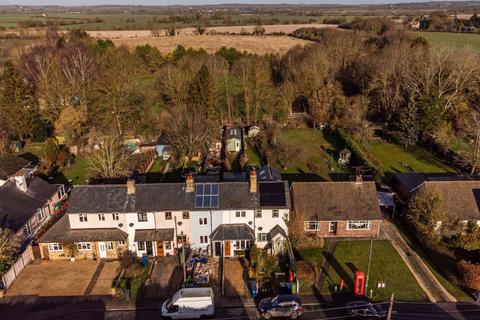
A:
[{"xmin": 380, "ymin": 220, "xmax": 457, "ymax": 303}]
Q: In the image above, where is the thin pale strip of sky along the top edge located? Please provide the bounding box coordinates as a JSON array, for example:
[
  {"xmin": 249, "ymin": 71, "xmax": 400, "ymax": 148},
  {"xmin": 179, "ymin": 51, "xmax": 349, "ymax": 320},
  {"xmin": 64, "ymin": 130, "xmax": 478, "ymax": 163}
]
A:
[{"xmin": 0, "ymin": 0, "xmax": 464, "ymax": 6}]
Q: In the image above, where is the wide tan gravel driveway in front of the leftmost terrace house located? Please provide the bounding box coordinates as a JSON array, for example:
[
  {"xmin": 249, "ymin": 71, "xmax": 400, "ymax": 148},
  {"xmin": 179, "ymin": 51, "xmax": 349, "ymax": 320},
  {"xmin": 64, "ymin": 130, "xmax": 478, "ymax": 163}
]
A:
[{"xmin": 7, "ymin": 261, "xmax": 118, "ymax": 297}]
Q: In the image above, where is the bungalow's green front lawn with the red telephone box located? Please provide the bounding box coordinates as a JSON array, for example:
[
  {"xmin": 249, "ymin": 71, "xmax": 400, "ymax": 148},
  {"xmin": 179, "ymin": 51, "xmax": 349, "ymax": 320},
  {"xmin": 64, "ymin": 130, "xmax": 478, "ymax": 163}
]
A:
[{"xmin": 321, "ymin": 240, "xmax": 426, "ymax": 301}]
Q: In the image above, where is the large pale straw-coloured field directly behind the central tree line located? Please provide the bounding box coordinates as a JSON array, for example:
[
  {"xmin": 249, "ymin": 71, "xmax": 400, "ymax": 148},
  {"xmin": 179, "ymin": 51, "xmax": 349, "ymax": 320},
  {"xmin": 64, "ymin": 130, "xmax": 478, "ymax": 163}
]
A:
[{"xmin": 113, "ymin": 35, "xmax": 311, "ymax": 54}]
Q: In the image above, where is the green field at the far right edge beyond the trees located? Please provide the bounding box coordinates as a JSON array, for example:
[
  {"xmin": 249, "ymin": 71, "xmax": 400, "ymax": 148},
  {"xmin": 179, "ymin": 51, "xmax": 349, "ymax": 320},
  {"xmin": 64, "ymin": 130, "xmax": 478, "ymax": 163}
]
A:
[{"xmin": 415, "ymin": 32, "xmax": 480, "ymax": 52}]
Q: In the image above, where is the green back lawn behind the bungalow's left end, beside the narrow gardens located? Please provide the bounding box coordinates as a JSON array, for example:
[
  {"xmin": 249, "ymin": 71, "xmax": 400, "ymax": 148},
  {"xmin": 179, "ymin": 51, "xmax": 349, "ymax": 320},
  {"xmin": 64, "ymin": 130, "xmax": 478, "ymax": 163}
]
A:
[{"xmin": 279, "ymin": 129, "xmax": 348, "ymax": 180}]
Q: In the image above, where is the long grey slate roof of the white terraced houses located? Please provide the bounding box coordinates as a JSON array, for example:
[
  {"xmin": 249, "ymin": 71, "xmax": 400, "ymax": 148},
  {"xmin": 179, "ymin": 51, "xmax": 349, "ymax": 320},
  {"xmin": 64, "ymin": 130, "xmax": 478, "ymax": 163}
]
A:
[{"xmin": 68, "ymin": 182, "xmax": 290, "ymax": 213}]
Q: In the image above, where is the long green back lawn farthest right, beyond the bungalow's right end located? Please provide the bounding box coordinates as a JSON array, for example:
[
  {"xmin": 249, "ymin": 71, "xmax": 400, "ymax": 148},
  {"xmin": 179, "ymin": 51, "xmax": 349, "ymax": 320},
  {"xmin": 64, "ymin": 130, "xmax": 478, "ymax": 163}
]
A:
[{"xmin": 366, "ymin": 141, "xmax": 455, "ymax": 173}]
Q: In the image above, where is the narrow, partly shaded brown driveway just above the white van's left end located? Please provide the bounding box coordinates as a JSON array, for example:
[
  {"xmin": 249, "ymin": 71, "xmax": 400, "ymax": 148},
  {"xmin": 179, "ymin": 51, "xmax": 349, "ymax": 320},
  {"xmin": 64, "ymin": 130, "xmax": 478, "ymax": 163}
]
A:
[{"xmin": 145, "ymin": 256, "xmax": 183, "ymax": 298}]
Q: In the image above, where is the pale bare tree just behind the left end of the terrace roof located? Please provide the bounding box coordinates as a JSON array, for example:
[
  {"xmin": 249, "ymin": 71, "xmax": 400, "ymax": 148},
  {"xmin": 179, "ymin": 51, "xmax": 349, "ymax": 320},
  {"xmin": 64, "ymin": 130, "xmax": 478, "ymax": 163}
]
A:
[{"xmin": 90, "ymin": 137, "xmax": 129, "ymax": 179}]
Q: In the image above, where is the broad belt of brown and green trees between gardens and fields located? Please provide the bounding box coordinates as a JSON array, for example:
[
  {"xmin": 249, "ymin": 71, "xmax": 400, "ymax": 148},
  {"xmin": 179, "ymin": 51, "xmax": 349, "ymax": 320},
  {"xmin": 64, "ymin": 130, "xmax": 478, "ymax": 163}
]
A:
[{"xmin": 0, "ymin": 24, "xmax": 480, "ymax": 172}]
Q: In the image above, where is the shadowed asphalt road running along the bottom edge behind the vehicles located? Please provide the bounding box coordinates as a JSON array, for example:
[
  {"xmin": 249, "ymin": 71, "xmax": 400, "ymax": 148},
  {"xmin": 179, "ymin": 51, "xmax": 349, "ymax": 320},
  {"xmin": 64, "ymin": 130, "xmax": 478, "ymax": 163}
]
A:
[{"xmin": 0, "ymin": 297, "xmax": 480, "ymax": 320}]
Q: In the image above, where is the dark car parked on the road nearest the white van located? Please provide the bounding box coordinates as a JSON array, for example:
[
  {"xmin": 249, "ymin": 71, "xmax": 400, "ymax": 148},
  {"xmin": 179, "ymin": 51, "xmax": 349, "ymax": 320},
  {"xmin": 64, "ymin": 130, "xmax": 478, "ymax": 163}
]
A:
[{"xmin": 258, "ymin": 294, "xmax": 303, "ymax": 319}]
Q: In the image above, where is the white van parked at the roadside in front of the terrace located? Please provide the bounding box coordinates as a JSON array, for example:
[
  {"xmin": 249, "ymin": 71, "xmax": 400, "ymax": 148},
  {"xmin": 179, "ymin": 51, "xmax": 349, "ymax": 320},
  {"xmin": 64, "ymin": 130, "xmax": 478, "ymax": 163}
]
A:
[{"xmin": 162, "ymin": 288, "xmax": 215, "ymax": 319}]
